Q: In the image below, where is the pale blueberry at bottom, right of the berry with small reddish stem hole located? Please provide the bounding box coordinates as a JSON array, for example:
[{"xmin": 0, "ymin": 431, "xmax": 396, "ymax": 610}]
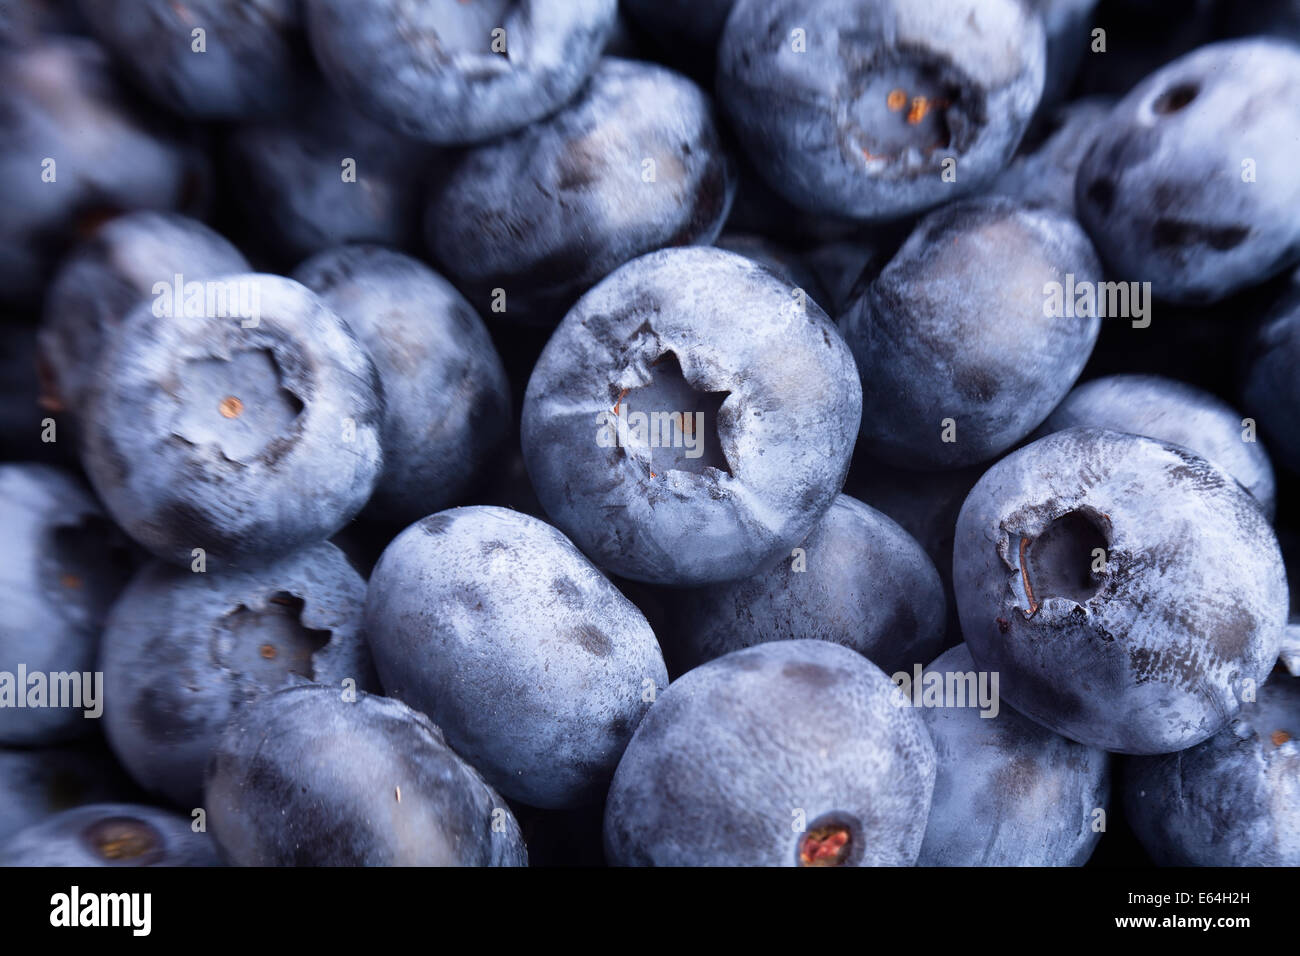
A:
[{"xmin": 917, "ymin": 644, "xmax": 1110, "ymax": 866}]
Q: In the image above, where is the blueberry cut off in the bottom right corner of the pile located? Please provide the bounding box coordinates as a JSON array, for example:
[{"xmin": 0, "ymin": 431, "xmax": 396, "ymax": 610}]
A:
[{"xmin": 1125, "ymin": 670, "xmax": 1300, "ymax": 866}]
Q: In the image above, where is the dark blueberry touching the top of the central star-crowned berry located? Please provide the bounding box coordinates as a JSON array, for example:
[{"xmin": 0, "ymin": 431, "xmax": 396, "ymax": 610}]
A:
[{"xmin": 425, "ymin": 57, "xmax": 736, "ymax": 326}]
